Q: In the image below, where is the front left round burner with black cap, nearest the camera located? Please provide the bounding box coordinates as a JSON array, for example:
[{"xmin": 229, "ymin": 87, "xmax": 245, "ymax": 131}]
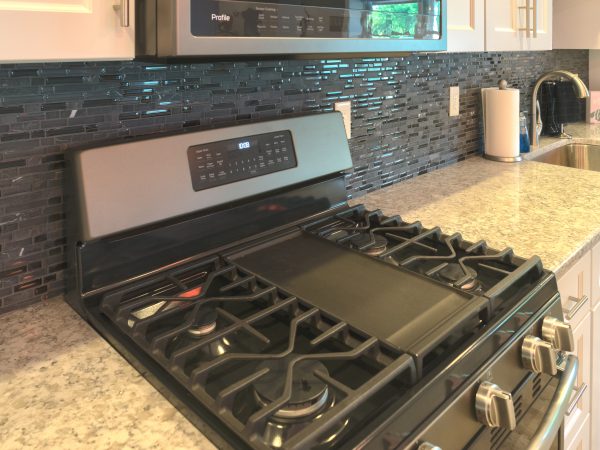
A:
[{"xmin": 253, "ymin": 355, "xmax": 329, "ymax": 419}]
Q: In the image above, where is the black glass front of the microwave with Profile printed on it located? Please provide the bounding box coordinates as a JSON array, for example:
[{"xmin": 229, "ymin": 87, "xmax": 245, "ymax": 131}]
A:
[{"xmin": 190, "ymin": 0, "xmax": 441, "ymax": 39}]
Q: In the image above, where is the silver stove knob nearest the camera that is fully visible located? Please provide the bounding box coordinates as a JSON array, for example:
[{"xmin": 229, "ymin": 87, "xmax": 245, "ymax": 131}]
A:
[{"xmin": 475, "ymin": 381, "xmax": 517, "ymax": 431}]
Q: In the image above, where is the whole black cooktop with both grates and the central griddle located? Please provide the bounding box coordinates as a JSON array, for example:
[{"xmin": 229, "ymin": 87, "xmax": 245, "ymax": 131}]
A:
[{"xmin": 88, "ymin": 208, "xmax": 543, "ymax": 449}]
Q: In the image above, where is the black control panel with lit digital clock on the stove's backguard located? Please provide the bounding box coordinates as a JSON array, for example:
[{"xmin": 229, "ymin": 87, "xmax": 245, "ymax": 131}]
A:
[{"xmin": 188, "ymin": 131, "xmax": 298, "ymax": 191}]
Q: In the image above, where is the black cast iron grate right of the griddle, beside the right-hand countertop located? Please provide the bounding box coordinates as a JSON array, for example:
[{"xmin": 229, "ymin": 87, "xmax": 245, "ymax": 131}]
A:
[{"xmin": 305, "ymin": 205, "xmax": 543, "ymax": 312}]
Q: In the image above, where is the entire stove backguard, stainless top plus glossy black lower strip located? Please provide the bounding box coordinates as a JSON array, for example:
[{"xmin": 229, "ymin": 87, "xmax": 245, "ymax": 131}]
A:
[{"xmin": 67, "ymin": 113, "xmax": 352, "ymax": 301}]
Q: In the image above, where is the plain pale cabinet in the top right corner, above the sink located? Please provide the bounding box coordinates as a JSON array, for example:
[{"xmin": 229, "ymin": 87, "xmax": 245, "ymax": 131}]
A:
[{"xmin": 554, "ymin": 0, "xmax": 600, "ymax": 50}]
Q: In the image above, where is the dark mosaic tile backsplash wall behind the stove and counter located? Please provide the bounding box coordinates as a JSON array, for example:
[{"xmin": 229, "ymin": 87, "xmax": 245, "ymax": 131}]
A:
[{"xmin": 0, "ymin": 51, "xmax": 589, "ymax": 312}]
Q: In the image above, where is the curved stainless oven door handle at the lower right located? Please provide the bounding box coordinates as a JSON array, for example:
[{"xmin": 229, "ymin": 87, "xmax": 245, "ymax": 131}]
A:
[{"xmin": 527, "ymin": 355, "xmax": 579, "ymax": 450}]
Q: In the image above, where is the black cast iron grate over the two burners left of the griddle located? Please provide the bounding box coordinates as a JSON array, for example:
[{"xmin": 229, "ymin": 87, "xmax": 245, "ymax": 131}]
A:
[{"xmin": 101, "ymin": 257, "xmax": 416, "ymax": 449}]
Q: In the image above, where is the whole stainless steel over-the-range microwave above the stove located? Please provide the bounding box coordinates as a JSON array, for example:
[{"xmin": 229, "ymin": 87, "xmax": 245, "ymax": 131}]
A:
[{"xmin": 136, "ymin": 0, "xmax": 447, "ymax": 58}]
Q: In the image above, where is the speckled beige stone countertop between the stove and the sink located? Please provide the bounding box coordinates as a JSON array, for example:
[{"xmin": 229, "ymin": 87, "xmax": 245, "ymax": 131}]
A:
[{"xmin": 353, "ymin": 125, "xmax": 600, "ymax": 276}]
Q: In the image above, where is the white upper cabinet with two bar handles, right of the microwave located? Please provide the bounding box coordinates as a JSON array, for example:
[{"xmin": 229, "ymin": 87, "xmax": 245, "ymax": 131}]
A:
[{"xmin": 485, "ymin": 0, "xmax": 552, "ymax": 51}]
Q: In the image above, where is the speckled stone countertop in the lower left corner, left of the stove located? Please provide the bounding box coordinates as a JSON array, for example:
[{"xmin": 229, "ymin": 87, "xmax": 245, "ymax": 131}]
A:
[{"xmin": 0, "ymin": 298, "xmax": 215, "ymax": 450}]
